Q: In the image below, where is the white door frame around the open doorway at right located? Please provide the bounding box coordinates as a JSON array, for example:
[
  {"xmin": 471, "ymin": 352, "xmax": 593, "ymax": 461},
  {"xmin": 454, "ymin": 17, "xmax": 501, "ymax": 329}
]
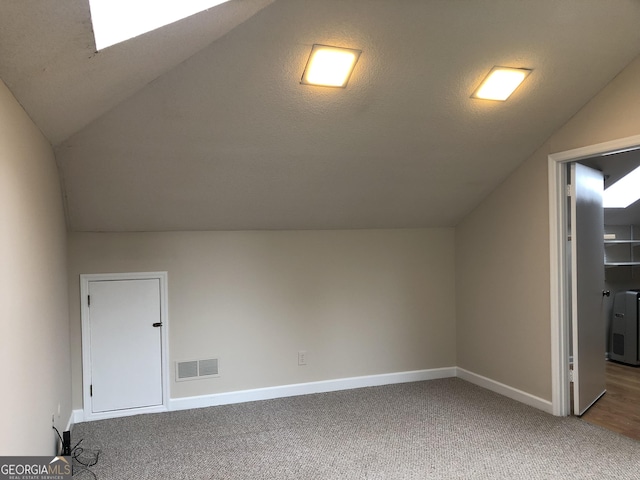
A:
[{"xmin": 548, "ymin": 135, "xmax": 640, "ymax": 416}]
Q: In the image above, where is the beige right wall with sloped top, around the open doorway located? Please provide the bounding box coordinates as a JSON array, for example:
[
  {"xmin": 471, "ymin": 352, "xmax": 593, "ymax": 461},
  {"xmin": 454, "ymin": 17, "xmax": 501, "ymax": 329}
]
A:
[{"xmin": 456, "ymin": 54, "xmax": 640, "ymax": 400}]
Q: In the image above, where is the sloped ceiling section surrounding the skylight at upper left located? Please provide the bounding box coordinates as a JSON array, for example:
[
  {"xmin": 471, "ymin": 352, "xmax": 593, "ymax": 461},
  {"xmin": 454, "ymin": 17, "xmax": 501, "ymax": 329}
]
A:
[{"xmin": 0, "ymin": 0, "xmax": 273, "ymax": 144}]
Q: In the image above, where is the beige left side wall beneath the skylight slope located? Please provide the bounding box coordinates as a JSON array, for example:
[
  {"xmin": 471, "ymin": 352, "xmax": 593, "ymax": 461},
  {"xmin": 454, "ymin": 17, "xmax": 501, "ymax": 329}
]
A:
[{"xmin": 0, "ymin": 81, "xmax": 71, "ymax": 455}]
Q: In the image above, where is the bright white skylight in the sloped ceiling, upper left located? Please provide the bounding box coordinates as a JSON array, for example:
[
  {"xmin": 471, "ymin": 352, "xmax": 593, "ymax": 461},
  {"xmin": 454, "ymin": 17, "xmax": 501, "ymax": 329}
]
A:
[{"xmin": 89, "ymin": 0, "xmax": 229, "ymax": 50}]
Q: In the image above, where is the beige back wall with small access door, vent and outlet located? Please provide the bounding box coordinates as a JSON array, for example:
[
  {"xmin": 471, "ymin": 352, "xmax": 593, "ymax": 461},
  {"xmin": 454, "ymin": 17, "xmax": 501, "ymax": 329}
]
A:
[{"xmin": 69, "ymin": 228, "xmax": 456, "ymax": 408}]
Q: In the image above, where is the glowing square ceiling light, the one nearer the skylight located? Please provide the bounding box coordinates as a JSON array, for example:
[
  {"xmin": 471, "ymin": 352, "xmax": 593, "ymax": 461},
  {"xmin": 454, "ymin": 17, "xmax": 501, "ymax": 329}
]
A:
[{"xmin": 300, "ymin": 44, "xmax": 362, "ymax": 88}]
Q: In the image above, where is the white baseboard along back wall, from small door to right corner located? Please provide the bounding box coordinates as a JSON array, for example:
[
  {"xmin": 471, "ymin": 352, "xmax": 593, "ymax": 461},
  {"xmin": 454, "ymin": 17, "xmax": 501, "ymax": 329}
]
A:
[{"xmin": 169, "ymin": 367, "xmax": 456, "ymax": 410}]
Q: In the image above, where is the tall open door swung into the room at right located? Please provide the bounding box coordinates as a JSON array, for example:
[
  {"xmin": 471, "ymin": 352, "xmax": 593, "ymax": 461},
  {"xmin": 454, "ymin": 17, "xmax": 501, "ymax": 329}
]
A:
[{"xmin": 570, "ymin": 163, "xmax": 606, "ymax": 415}]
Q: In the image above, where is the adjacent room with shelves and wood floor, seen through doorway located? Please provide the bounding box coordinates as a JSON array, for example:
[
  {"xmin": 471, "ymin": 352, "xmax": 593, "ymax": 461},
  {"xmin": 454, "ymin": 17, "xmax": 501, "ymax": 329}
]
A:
[{"xmin": 580, "ymin": 150, "xmax": 640, "ymax": 438}]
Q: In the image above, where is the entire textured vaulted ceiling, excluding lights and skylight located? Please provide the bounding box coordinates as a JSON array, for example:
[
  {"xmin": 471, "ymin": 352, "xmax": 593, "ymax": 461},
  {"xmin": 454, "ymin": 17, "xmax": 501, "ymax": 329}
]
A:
[{"xmin": 0, "ymin": 0, "xmax": 640, "ymax": 231}]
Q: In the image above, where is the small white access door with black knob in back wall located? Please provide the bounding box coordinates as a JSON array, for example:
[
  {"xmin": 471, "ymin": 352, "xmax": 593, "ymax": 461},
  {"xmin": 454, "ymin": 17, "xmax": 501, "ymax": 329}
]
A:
[{"xmin": 87, "ymin": 278, "xmax": 163, "ymax": 413}]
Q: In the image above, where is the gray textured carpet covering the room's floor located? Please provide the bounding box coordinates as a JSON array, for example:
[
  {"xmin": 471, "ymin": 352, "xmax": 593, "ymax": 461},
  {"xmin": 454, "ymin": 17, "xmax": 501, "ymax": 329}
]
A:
[{"xmin": 72, "ymin": 378, "xmax": 640, "ymax": 480}]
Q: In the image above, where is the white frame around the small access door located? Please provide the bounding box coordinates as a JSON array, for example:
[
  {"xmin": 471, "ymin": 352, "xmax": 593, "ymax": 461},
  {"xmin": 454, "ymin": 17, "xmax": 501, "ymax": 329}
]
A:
[{"xmin": 80, "ymin": 272, "xmax": 169, "ymax": 421}]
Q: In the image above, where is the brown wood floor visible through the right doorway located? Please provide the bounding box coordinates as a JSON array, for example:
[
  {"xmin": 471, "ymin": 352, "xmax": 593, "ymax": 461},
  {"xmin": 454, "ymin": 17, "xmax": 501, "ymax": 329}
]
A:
[{"xmin": 581, "ymin": 362, "xmax": 640, "ymax": 440}]
